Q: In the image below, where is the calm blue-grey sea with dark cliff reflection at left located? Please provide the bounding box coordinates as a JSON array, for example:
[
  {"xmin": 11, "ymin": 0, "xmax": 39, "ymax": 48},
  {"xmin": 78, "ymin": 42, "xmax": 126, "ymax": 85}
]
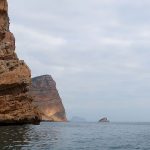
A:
[{"xmin": 0, "ymin": 122, "xmax": 150, "ymax": 150}]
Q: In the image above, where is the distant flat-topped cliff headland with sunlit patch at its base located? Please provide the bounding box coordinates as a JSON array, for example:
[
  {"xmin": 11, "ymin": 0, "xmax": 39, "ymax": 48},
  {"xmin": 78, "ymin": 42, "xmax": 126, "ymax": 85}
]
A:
[{"xmin": 30, "ymin": 75, "xmax": 67, "ymax": 121}]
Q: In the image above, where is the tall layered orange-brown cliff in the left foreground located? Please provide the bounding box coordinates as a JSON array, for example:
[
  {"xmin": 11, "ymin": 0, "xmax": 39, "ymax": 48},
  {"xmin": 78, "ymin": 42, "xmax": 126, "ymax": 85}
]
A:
[{"xmin": 0, "ymin": 0, "xmax": 40, "ymax": 125}]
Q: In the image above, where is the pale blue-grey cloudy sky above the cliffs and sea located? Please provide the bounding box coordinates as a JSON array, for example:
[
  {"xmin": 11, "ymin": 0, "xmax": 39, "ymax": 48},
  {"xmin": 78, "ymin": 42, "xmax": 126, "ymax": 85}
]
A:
[{"xmin": 8, "ymin": 0, "xmax": 150, "ymax": 121}]
